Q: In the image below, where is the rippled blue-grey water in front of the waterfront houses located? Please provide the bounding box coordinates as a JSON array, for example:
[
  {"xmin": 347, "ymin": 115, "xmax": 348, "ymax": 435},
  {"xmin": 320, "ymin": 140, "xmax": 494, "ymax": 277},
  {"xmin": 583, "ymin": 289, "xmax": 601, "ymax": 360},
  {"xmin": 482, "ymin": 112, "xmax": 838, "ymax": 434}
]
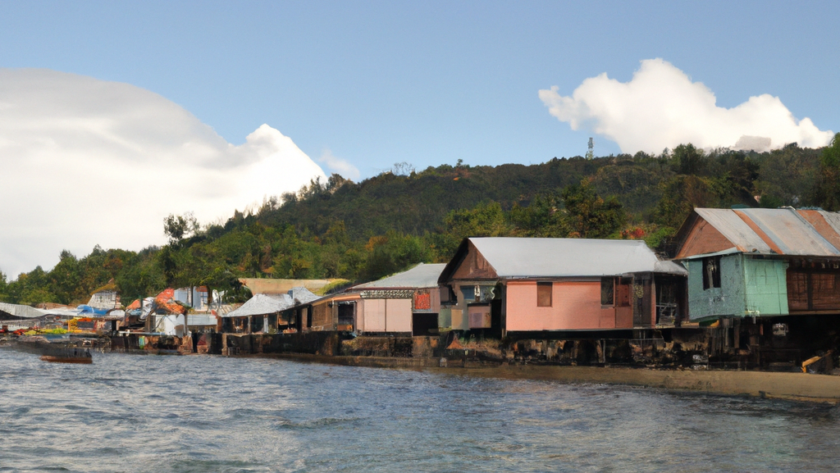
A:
[{"xmin": 0, "ymin": 349, "xmax": 840, "ymax": 472}]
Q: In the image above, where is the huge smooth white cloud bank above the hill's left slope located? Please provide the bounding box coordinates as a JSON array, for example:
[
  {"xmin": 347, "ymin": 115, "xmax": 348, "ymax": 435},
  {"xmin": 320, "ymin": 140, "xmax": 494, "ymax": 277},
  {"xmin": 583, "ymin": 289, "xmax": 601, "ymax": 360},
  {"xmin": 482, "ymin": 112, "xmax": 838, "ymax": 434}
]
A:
[{"xmin": 0, "ymin": 69, "xmax": 326, "ymax": 277}]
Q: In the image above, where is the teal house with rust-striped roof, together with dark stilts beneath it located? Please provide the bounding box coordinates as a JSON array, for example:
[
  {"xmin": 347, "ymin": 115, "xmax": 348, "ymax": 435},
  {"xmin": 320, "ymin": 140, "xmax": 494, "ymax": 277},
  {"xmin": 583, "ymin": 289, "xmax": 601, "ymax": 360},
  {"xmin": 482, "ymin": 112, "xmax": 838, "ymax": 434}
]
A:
[{"xmin": 676, "ymin": 208, "xmax": 840, "ymax": 366}]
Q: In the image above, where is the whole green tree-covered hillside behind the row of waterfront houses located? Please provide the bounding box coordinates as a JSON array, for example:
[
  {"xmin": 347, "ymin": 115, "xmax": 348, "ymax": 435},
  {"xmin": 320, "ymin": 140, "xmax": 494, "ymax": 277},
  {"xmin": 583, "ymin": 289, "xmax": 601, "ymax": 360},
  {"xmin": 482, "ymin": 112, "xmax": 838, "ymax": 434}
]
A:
[{"xmin": 0, "ymin": 134, "xmax": 840, "ymax": 304}]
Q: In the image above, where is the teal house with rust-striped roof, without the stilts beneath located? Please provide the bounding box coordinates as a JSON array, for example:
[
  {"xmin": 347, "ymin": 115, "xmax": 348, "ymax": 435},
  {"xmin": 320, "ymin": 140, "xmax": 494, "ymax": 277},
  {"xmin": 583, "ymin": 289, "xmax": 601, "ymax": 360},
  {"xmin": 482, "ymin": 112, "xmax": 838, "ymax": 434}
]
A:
[{"xmin": 675, "ymin": 208, "xmax": 840, "ymax": 321}]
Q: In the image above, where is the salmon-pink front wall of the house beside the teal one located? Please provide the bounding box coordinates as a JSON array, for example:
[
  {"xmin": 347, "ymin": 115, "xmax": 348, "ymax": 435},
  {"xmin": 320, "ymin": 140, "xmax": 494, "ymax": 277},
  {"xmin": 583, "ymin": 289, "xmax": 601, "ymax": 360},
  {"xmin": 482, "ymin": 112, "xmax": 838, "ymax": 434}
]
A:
[{"xmin": 506, "ymin": 281, "xmax": 615, "ymax": 331}]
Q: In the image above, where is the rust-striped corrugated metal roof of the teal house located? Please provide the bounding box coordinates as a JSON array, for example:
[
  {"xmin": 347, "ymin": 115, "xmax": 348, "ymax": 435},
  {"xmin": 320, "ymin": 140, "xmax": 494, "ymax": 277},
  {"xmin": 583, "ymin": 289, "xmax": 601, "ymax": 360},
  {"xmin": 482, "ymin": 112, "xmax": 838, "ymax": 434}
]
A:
[{"xmin": 677, "ymin": 208, "xmax": 840, "ymax": 258}]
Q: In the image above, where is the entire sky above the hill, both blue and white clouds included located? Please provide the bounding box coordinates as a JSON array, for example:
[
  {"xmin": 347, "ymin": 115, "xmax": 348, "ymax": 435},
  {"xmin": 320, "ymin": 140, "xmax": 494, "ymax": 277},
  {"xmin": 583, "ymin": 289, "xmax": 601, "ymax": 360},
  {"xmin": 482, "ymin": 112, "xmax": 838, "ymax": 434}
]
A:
[{"xmin": 0, "ymin": 0, "xmax": 840, "ymax": 278}]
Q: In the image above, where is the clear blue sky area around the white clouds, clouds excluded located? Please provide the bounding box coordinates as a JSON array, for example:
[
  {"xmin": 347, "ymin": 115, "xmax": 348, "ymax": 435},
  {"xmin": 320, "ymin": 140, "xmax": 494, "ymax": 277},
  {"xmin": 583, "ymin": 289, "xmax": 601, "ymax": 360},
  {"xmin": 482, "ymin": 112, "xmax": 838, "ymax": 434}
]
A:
[{"xmin": 0, "ymin": 1, "xmax": 840, "ymax": 177}]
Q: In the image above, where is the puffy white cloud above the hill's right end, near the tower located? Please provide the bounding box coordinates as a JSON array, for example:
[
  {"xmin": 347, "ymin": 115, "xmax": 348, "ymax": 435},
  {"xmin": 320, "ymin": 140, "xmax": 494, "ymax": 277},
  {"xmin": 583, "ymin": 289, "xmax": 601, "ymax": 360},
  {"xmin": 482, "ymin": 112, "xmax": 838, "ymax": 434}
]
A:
[{"xmin": 539, "ymin": 59, "xmax": 833, "ymax": 153}]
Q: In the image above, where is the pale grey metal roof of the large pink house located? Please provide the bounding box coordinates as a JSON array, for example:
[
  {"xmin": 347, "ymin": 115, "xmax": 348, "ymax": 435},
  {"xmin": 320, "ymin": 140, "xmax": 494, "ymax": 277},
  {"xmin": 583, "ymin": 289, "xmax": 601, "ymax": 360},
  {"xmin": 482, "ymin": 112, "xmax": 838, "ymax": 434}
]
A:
[{"xmin": 470, "ymin": 238, "xmax": 687, "ymax": 278}]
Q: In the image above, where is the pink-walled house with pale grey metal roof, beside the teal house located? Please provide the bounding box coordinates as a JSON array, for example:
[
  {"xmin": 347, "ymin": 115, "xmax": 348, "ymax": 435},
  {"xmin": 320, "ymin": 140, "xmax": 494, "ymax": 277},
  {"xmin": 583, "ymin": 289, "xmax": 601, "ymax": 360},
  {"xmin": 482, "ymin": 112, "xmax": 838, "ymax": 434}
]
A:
[{"xmin": 438, "ymin": 238, "xmax": 687, "ymax": 334}]
